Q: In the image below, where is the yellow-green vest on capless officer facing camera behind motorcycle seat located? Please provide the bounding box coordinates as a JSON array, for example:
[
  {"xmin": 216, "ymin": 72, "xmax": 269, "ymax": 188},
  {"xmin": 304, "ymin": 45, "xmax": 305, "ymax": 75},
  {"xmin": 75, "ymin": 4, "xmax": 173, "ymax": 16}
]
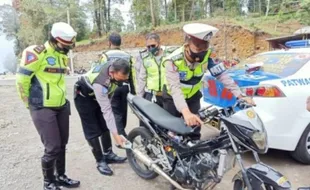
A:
[{"xmin": 140, "ymin": 46, "xmax": 176, "ymax": 92}]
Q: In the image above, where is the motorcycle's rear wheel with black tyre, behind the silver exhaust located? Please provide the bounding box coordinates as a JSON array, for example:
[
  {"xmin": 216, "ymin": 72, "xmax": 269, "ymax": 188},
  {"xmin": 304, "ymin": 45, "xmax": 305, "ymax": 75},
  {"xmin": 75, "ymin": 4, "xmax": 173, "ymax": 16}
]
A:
[{"xmin": 126, "ymin": 127, "xmax": 158, "ymax": 180}]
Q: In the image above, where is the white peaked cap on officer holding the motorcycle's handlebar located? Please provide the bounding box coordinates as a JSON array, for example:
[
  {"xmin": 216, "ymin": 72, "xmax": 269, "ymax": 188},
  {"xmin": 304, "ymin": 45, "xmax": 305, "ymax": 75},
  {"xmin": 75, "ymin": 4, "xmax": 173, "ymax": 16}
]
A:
[{"xmin": 183, "ymin": 23, "xmax": 219, "ymax": 41}]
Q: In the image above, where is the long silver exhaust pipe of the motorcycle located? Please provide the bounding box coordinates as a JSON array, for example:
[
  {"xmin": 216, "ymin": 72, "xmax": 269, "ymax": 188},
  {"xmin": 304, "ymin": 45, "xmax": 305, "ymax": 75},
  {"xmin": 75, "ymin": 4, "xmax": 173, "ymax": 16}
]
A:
[{"xmin": 132, "ymin": 149, "xmax": 189, "ymax": 190}]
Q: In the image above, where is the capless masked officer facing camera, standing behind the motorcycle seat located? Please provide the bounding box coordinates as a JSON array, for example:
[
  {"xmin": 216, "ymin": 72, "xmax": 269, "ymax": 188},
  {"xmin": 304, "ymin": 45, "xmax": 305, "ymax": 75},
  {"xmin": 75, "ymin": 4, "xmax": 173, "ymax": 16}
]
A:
[{"xmin": 137, "ymin": 33, "xmax": 178, "ymax": 107}]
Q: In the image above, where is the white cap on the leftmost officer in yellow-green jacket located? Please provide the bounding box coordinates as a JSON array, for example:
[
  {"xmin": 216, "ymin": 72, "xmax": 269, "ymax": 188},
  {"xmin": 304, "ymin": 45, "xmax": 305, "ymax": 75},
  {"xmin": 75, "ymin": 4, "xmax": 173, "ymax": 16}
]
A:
[{"xmin": 51, "ymin": 22, "xmax": 77, "ymax": 46}]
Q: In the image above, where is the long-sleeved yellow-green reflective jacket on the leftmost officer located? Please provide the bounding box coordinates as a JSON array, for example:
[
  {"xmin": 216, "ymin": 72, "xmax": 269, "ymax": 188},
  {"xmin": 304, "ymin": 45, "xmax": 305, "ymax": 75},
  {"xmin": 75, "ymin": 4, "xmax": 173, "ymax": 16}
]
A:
[{"xmin": 16, "ymin": 42, "xmax": 68, "ymax": 108}]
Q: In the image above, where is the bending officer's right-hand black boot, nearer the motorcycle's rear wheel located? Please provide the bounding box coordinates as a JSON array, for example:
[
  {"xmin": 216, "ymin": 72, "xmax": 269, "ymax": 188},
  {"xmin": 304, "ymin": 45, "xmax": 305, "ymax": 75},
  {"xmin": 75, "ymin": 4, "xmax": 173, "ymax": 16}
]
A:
[{"xmin": 100, "ymin": 133, "xmax": 127, "ymax": 164}]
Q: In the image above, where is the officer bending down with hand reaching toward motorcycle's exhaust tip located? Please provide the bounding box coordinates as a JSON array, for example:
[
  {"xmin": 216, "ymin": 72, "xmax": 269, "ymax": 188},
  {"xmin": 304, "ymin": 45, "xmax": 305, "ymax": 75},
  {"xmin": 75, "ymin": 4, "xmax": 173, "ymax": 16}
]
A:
[{"xmin": 74, "ymin": 58, "xmax": 130, "ymax": 175}]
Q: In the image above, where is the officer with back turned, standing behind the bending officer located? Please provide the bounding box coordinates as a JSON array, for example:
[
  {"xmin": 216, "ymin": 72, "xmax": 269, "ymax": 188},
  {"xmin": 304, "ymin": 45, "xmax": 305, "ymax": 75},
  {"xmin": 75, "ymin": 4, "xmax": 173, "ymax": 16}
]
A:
[{"xmin": 101, "ymin": 32, "xmax": 136, "ymax": 138}]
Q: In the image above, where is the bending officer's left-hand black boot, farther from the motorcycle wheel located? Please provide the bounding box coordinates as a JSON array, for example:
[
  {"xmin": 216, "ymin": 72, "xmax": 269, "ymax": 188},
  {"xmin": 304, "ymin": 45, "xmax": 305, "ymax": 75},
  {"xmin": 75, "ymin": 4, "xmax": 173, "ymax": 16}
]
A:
[{"xmin": 88, "ymin": 138, "xmax": 113, "ymax": 176}]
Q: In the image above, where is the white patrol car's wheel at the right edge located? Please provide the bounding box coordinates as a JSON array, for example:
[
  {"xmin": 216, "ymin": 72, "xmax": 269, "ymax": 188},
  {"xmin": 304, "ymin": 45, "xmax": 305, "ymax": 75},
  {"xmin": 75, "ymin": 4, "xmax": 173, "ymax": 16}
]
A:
[{"xmin": 291, "ymin": 125, "xmax": 310, "ymax": 165}]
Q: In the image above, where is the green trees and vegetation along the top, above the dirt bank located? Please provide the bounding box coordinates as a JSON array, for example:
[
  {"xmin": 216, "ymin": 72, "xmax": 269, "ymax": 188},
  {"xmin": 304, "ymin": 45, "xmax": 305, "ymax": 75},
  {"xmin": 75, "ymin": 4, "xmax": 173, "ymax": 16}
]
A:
[{"xmin": 0, "ymin": 0, "xmax": 310, "ymax": 55}]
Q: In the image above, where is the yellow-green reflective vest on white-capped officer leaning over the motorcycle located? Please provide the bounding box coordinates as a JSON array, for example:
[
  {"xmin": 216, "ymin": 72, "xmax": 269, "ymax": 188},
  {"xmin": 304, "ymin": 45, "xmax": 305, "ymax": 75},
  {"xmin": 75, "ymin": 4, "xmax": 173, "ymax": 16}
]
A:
[{"xmin": 162, "ymin": 46, "xmax": 211, "ymax": 99}]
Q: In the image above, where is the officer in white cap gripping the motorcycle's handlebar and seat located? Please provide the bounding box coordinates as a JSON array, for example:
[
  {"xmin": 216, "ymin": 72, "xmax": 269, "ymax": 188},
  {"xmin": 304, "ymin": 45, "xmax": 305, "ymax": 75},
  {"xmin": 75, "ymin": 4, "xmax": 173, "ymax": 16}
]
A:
[{"xmin": 162, "ymin": 23, "xmax": 254, "ymax": 139}]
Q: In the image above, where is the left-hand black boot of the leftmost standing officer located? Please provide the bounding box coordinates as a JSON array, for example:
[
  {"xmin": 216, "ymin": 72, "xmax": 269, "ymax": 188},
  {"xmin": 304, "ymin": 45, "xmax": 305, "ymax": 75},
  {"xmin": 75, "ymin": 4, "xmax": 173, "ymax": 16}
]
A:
[{"xmin": 41, "ymin": 159, "xmax": 61, "ymax": 190}]
